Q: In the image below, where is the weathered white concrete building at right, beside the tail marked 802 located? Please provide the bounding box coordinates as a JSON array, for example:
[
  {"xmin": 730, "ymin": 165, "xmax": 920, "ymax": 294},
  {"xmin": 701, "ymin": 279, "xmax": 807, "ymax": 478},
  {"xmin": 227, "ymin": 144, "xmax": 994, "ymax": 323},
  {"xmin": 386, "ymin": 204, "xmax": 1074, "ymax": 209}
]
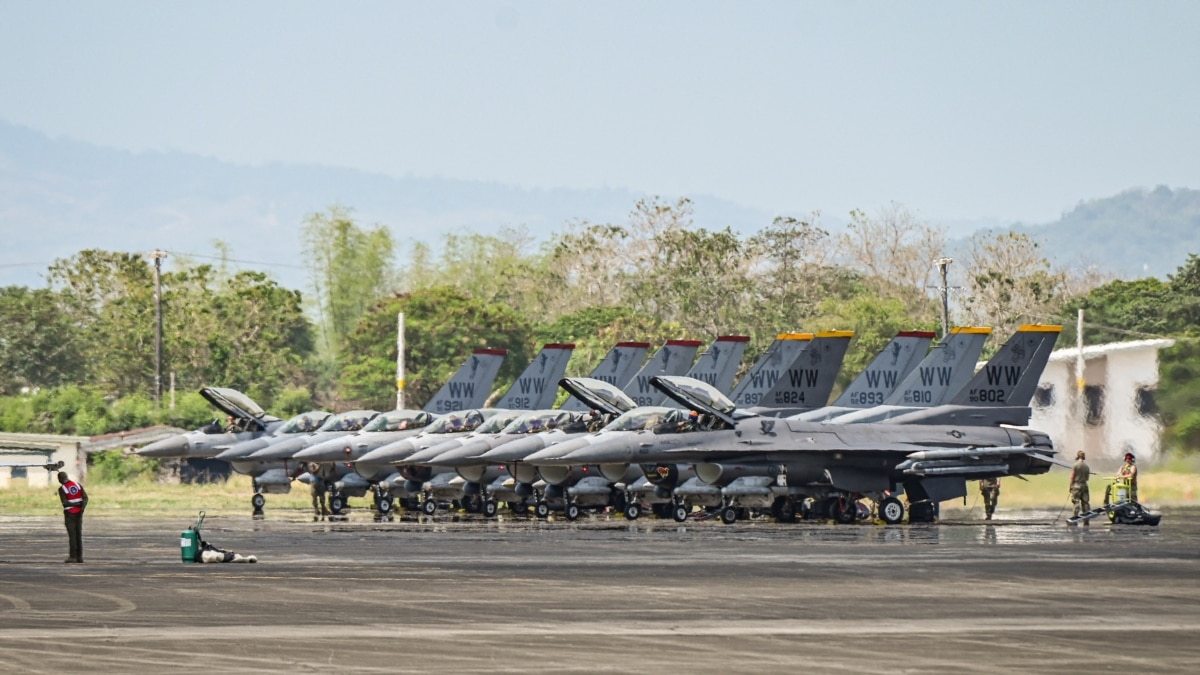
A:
[{"xmin": 1030, "ymin": 340, "xmax": 1175, "ymax": 462}]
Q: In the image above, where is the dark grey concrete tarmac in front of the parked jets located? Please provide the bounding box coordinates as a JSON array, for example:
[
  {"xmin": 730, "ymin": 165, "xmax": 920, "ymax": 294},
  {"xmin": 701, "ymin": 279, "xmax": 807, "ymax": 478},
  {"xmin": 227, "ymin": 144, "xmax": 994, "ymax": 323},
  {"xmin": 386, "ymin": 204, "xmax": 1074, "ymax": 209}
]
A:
[{"xmin": 0, "ymin": 508, "xmax": 1200, "ymax": 674}]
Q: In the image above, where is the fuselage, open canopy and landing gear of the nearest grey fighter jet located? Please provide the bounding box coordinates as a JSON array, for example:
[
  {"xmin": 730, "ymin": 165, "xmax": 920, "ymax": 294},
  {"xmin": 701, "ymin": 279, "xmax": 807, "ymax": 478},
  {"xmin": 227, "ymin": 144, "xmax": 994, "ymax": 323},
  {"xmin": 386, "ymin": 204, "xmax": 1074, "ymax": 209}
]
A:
[{"xmin": 540, "ymin": 377, "xmax": 1066, "ymax": 522}]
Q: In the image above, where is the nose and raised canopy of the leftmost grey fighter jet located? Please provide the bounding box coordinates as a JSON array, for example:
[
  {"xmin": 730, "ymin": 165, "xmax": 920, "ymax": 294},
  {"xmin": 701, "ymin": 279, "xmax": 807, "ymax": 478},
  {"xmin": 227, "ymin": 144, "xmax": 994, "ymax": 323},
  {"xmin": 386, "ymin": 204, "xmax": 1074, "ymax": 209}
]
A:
[{"xmin": 137, "ymin": 387, "xmax": 283, "ymax": 458}]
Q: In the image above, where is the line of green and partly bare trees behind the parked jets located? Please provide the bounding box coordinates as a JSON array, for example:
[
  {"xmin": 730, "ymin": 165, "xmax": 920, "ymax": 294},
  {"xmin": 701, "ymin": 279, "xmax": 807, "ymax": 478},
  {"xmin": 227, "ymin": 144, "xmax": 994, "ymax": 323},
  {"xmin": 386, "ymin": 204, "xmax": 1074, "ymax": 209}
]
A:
[{"xmin": 0, "ymin": 198, "xmax": 1200, "ymax": 448}]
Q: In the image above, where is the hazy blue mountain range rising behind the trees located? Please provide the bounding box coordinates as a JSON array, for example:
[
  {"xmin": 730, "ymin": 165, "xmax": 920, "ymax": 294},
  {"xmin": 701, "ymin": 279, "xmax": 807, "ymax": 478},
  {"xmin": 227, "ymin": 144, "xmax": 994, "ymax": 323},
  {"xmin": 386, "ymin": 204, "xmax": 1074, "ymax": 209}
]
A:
[{"xmin": 0, "ymin": 121, "xmax": 1200, "ymax": 288}]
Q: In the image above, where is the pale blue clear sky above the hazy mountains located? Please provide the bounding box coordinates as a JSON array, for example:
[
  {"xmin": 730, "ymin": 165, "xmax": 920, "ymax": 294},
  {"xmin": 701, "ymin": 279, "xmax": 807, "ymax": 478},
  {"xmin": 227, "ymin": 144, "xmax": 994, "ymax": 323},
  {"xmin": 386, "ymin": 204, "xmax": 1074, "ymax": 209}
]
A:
[{"xmin": 0, "ymin": 0, "xmax": 1200, "ymax": 222}]
